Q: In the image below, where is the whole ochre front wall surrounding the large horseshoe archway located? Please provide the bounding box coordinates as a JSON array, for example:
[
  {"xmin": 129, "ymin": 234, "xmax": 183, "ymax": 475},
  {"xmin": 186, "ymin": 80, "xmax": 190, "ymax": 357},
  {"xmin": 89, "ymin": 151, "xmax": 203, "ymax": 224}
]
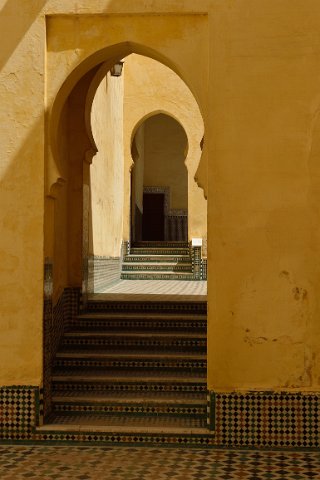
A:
[{"xmin": 0, "ymin": 0, "xmax": 320, "ymax": 398}]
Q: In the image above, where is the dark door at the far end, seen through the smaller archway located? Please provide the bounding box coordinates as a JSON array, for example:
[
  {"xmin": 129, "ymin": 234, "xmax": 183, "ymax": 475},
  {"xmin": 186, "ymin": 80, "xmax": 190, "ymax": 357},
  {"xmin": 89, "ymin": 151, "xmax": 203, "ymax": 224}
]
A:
[{"xmin": 142, "ymin": 193, "xmax": 164, "ymax": 241}]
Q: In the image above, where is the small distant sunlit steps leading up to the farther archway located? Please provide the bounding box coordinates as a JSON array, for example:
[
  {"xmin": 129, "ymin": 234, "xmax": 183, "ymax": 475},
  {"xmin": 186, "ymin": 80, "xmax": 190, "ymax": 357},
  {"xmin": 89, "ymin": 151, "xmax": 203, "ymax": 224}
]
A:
[{"xmin": 121, "ymin": 242, "xmax": 194, "ymax": 280}]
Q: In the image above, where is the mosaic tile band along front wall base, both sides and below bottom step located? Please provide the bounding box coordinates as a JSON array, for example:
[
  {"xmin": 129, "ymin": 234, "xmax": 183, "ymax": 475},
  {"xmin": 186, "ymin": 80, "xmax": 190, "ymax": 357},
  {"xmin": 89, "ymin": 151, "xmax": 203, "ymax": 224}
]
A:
[{"xmin": 0, "ymin": 386, "xmax": 320, "ymax": 449}]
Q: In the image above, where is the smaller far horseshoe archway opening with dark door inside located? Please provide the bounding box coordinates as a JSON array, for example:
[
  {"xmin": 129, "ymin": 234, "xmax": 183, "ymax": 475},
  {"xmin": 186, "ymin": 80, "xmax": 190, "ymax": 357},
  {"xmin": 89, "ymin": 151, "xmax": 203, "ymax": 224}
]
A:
[{"xmin": 131, "ymin": 113, "xmax": 188, "ymax": 243}]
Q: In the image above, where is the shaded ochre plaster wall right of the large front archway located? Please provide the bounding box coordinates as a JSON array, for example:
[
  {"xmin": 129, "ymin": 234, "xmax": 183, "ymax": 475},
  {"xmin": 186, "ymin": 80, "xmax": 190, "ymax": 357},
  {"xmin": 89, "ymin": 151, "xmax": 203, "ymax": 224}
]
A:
[{"xmin": 208, "ymin": 0, "xmax": 320, "ymax": 390}]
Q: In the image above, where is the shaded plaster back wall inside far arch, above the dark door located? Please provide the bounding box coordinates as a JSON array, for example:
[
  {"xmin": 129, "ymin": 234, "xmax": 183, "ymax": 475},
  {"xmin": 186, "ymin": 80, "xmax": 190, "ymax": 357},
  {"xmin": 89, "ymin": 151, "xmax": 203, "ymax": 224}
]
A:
[{"xmin": 144, "ymin": 114, "xmax": 188, "ymax": 210}]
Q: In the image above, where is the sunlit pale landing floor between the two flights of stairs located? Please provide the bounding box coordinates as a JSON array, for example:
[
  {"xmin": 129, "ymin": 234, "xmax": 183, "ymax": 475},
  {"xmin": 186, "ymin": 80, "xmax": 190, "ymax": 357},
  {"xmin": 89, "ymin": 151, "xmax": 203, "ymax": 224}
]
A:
[{"xmin": 95, "ymin": 280, "xmax": 207, "ymax": 295}]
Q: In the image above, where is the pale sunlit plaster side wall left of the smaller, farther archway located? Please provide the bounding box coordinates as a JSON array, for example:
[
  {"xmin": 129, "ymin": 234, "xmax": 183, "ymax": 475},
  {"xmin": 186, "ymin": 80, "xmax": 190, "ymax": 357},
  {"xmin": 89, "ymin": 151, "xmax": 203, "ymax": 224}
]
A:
[{"xmin": 89, "ymin": 70, "xmax": 124, "ymax": 257}]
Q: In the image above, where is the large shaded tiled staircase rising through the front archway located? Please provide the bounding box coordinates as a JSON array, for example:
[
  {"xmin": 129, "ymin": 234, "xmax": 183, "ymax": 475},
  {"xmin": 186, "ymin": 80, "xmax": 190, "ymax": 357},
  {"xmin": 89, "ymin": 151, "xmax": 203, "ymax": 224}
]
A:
[{"xmin": 46, "ymin": 300, "xmax": 208, "ymax": 438}]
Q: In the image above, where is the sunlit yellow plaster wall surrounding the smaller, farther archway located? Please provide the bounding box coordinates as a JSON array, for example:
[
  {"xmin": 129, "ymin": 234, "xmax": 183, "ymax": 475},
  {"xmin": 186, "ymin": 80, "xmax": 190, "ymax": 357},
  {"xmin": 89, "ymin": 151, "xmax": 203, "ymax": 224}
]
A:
[{"xmin": 124, "ymin": 54, "xmax": 207, "ymax": 239}]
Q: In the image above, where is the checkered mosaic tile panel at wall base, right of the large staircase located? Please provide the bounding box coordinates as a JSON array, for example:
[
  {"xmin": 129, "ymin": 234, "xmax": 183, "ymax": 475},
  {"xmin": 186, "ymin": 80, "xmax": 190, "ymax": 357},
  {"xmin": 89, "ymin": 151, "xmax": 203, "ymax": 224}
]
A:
[{"xmin": 215, "ymin": 392, "xmax": 320, "ymax": 448}]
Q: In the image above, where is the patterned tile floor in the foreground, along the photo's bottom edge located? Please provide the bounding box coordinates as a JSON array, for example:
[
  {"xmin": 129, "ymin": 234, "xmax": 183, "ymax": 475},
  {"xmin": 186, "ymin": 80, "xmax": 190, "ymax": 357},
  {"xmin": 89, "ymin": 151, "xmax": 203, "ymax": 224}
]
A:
[{"xmin": 0, "ymin": 445, "xmax": 320, "ymax": 480}]
